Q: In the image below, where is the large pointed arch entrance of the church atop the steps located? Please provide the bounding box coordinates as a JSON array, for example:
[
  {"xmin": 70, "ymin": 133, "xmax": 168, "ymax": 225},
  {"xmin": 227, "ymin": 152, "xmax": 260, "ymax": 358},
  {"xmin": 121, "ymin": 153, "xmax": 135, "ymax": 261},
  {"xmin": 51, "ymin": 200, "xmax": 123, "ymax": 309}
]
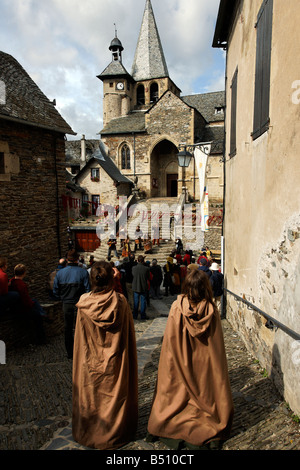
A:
[{"xmin": 150, "ymin": 139, "xmax": 179, "ymax": 197}]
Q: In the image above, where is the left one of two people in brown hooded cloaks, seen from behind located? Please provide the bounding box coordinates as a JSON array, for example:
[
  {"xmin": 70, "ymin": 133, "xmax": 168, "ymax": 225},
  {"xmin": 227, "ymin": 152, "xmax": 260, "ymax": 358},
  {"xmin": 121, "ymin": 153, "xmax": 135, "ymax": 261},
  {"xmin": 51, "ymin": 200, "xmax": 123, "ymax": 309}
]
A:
[{"xmin": 72, "ymin": 261, "xmax": 138, "ymax": 450}]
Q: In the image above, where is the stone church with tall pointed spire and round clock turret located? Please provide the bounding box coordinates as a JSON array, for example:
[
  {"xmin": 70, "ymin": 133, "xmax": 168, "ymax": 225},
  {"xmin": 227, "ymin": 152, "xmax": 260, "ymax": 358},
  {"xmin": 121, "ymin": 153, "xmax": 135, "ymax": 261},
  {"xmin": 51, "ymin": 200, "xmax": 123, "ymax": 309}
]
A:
[{"xmin": 67, "ymin": 0, "xmax": 225, "ymax": 215}]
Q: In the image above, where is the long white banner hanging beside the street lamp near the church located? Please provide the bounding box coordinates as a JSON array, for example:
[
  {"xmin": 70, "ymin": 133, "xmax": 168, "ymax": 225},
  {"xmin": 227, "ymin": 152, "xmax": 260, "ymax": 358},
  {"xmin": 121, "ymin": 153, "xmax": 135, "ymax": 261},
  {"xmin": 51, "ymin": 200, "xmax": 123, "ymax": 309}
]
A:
[{"xmin": 194, "ymin": 144, "xmax": 211, "ymax": 232}]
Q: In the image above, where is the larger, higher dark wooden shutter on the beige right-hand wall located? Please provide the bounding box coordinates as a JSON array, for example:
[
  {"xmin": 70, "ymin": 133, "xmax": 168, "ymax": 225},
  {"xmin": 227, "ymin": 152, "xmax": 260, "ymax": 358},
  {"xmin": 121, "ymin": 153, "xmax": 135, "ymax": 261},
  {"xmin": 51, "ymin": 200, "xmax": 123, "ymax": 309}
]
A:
[{"xmin": 252, "ymin": 0, "xmax": 273, "ymax": 139}]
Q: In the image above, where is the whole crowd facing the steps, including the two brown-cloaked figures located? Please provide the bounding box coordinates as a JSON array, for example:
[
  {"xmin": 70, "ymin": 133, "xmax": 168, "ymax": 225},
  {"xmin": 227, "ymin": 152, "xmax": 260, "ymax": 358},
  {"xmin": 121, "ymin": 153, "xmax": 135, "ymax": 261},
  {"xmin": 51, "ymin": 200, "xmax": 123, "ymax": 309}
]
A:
[{"xmin": 0, "ymin": 240, "xmax": 233, "ymax": 449}]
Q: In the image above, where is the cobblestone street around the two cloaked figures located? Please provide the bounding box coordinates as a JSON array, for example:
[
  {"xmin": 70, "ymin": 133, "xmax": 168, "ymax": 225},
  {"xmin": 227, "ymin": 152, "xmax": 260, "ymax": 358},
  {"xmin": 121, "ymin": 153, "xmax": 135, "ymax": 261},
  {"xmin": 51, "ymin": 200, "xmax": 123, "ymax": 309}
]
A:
[{"xmin": 0, "ymin": 297, "xmax": 300, "ymax": 451}]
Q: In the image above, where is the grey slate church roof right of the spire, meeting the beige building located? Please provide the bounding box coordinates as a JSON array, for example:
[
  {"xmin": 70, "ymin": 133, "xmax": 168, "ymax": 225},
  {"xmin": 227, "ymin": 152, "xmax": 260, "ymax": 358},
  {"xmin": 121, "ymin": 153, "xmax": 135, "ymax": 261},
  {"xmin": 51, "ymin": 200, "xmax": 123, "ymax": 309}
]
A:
[{"xmin": 181, "ymin": 91, "xmax": 225, "ymax": 122}]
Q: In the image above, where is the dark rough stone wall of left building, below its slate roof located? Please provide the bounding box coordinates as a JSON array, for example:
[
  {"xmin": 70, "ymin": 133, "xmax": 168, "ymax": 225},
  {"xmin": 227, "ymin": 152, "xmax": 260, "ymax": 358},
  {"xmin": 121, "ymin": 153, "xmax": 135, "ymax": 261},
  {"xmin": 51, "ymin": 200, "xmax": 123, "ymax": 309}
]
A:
[{"xmin": 0, "ymin": 121, "xmax": 67, "ymax": 299}]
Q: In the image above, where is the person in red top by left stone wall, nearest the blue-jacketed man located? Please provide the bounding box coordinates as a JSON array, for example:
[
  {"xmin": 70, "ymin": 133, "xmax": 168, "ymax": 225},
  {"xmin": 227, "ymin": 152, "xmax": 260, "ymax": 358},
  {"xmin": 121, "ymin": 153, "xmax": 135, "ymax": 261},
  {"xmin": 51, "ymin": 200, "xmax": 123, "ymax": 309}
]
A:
[{"xmin": 9, "ymin": 264, "xmax": 46, "ymax": 344}]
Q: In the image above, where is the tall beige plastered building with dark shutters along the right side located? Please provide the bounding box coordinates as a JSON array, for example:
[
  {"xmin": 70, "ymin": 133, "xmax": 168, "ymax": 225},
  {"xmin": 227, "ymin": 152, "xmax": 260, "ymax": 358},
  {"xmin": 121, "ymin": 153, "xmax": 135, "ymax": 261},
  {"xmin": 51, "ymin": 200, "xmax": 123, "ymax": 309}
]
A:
[{"xmin": 213, "ymin": 0, "xmax": 300, "ymax": 415}]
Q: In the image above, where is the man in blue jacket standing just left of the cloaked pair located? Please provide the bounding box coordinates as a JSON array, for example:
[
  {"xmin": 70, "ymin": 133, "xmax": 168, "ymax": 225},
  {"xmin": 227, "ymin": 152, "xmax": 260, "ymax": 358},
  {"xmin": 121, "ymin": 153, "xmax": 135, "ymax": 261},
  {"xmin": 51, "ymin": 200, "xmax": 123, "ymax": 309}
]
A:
[{"xmin": 53, "ymin": 250, "xmax": 90, "ymax": 359}]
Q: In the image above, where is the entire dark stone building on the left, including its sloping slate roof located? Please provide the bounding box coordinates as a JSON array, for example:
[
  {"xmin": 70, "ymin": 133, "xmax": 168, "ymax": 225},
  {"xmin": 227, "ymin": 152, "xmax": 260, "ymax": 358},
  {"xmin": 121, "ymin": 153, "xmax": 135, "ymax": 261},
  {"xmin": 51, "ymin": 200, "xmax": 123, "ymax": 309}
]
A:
[{"xmin": 0, "ymin": 52, "xmax": 74, "ymax": 299}]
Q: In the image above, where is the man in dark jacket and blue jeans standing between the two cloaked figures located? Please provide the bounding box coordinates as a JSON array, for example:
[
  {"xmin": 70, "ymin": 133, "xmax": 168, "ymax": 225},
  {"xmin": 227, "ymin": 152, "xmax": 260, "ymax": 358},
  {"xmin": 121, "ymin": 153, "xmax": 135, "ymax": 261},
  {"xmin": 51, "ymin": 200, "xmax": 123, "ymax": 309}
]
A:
[{"xmin": 132, "ymin": 255, "xmax": 150, "ymax": 320}]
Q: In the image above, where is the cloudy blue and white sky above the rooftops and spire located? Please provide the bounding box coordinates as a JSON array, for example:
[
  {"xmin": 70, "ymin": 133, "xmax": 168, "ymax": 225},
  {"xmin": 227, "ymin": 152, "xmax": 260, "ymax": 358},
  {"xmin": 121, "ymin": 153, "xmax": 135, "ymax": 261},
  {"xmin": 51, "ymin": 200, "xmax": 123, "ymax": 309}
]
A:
[{"xmin": 0, "ymin": 0, "xmax": 225, "ymax": 140}]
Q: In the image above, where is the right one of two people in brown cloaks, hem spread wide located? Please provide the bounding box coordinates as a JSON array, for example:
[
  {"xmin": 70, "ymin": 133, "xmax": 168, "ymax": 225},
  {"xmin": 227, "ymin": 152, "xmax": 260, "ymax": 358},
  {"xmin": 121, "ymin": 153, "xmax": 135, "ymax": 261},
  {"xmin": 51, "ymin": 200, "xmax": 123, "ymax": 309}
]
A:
[{"xmin": 147, "ymin": 270, "xmax": 233, "ymax": 449}]
